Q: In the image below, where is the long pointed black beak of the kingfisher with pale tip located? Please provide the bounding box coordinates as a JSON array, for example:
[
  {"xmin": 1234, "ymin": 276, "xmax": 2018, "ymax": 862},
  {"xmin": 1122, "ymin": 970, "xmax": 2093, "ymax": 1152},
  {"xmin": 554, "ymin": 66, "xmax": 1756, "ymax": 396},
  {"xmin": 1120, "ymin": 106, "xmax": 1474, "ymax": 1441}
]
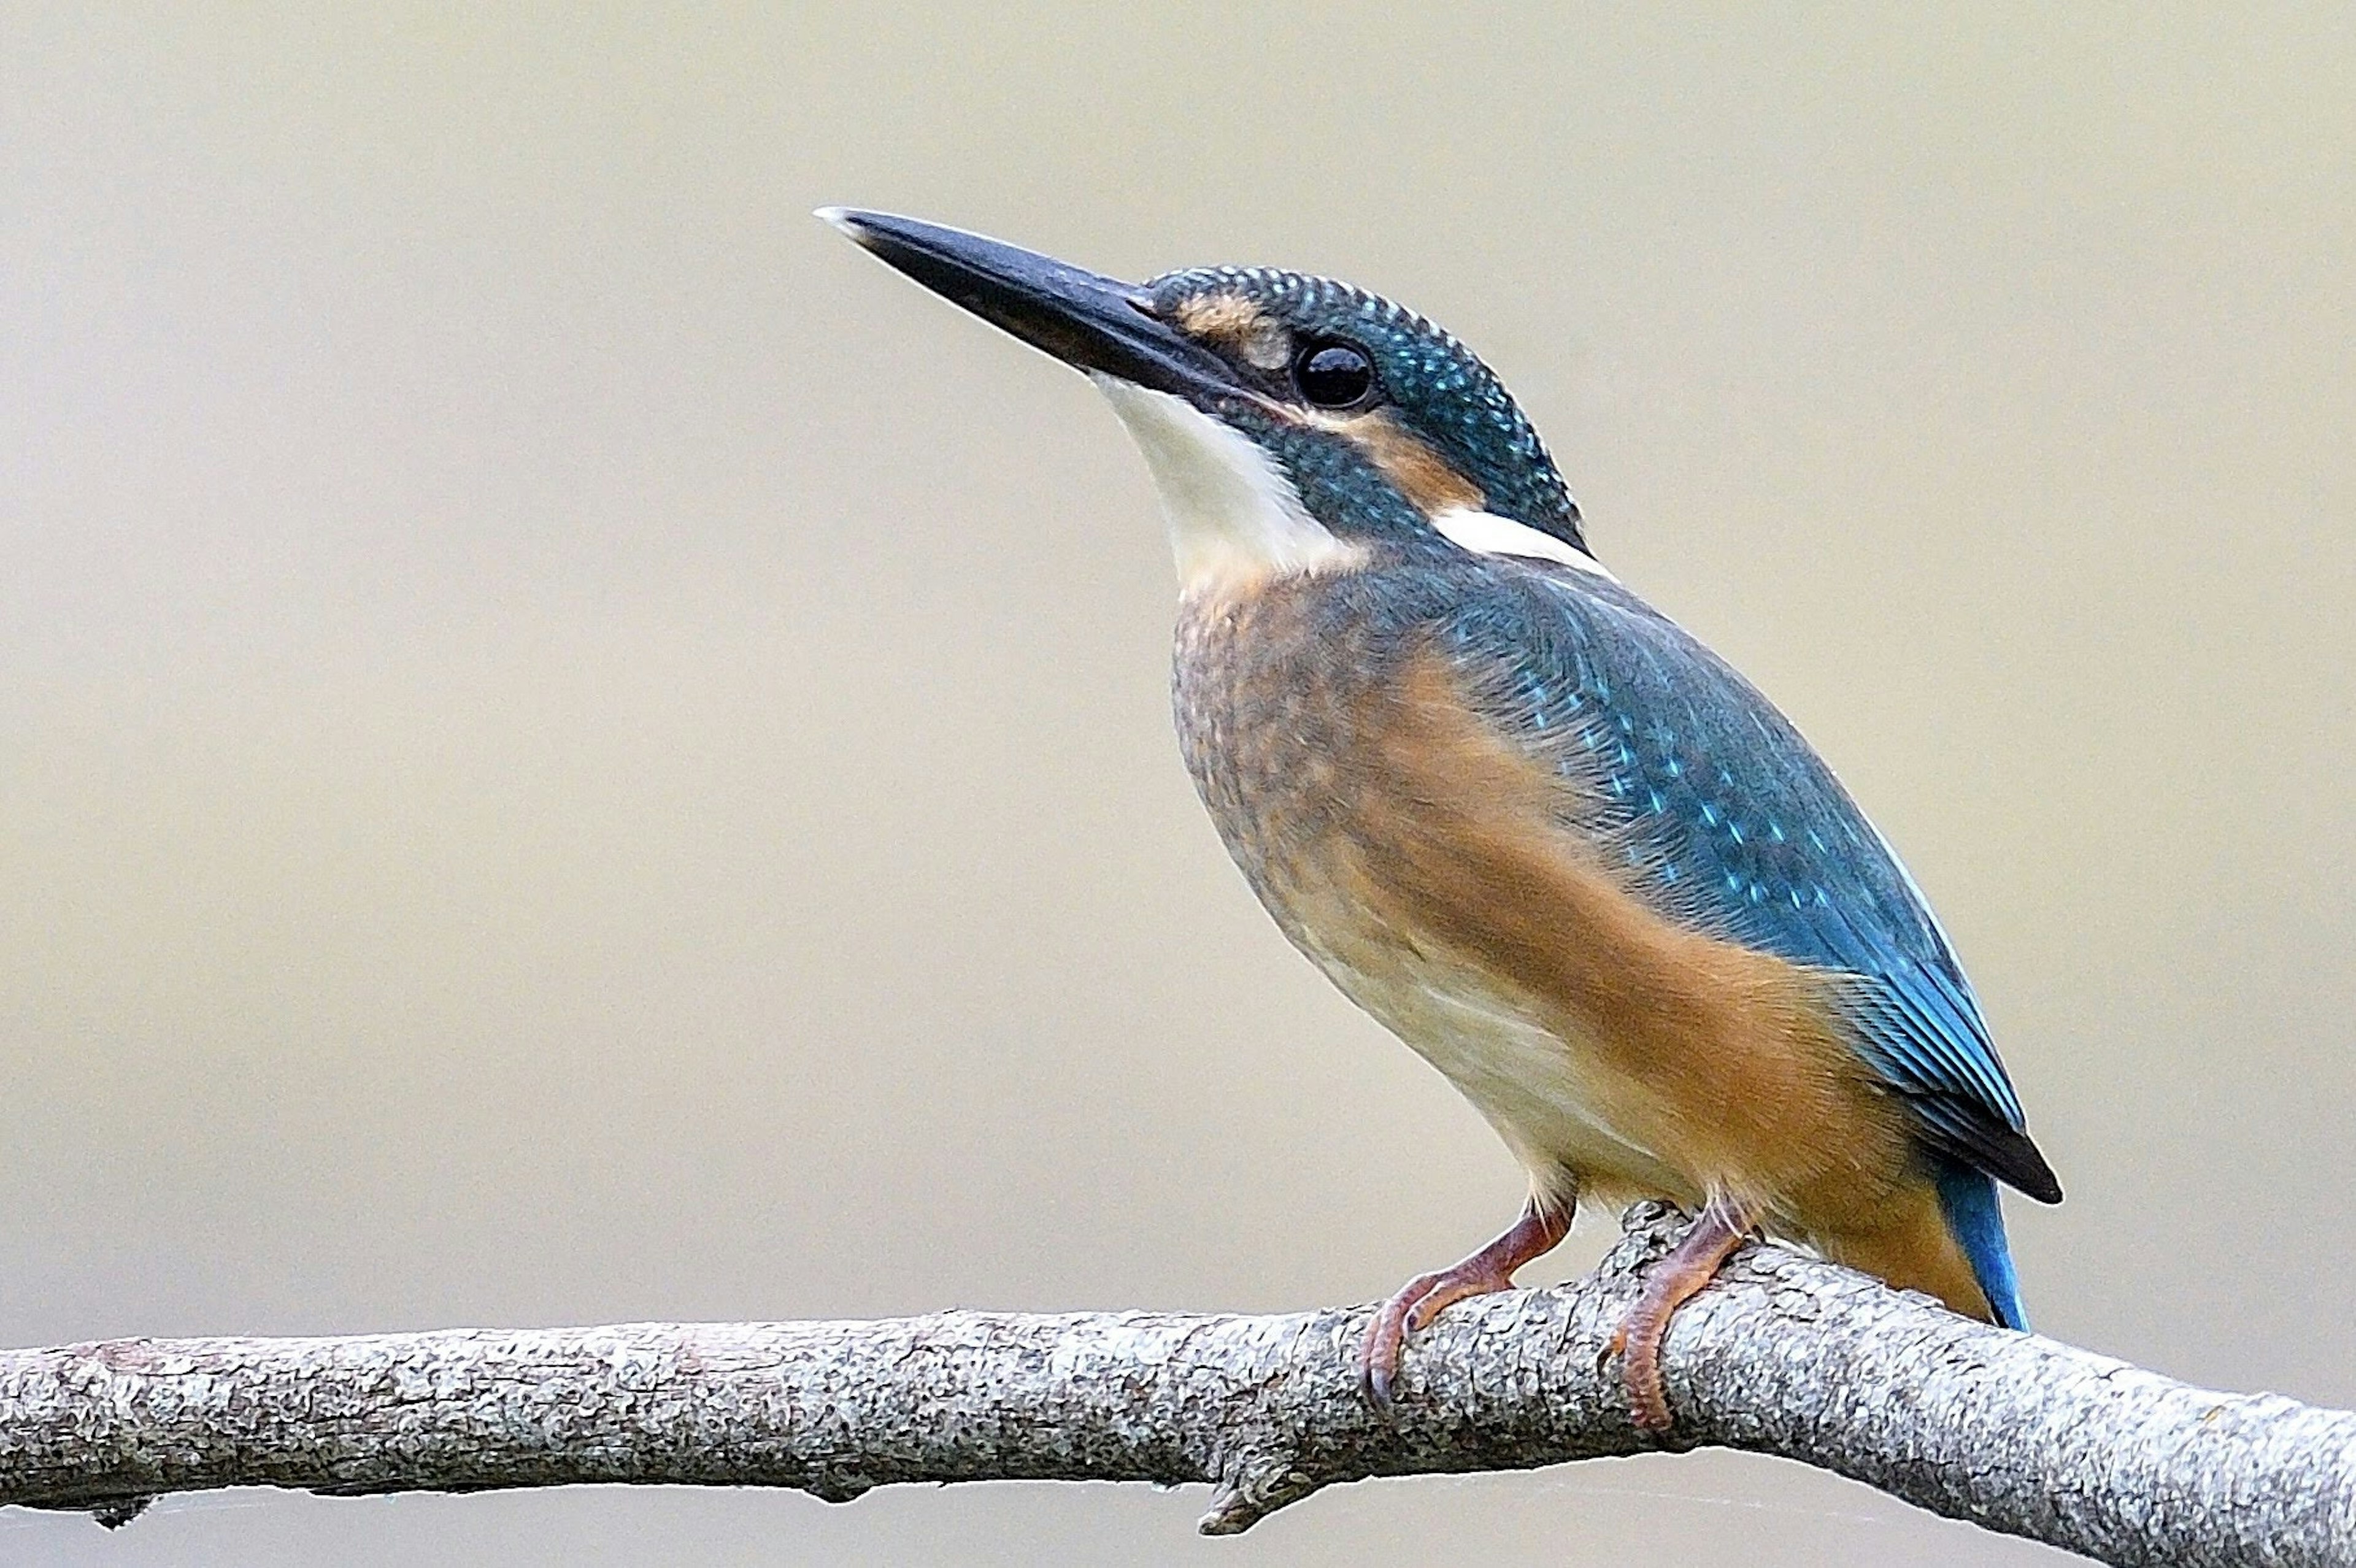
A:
[{"xmin": 817, "ymin": 207, "xmax": 1242, "ymax": 402}]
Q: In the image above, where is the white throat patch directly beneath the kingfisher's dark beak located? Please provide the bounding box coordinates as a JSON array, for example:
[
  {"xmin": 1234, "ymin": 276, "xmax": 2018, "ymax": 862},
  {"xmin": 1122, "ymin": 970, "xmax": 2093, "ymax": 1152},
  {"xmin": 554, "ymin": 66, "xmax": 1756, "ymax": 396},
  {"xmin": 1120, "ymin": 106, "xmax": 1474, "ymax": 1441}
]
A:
[{"xmin": 1088, "ymin": 374, "xmax": 1360, "ymax": 588}]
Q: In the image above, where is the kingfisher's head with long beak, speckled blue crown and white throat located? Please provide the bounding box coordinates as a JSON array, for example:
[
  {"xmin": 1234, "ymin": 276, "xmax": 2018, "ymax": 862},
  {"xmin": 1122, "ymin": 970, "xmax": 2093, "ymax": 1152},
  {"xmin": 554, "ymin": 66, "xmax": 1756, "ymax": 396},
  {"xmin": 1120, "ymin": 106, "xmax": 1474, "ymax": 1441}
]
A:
[{"xmin": 820, "ymin": 207, "xmax": 1593, "ymax": 586}]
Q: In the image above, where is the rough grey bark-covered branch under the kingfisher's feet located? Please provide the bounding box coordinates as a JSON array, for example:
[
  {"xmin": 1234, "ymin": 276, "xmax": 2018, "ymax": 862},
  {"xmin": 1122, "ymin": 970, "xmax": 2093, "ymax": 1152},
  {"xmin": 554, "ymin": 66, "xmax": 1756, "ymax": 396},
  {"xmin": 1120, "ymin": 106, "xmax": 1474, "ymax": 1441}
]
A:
[{"xmin": 0, "ymin": 1205, "xmax": 2356, "ymax": 1568}]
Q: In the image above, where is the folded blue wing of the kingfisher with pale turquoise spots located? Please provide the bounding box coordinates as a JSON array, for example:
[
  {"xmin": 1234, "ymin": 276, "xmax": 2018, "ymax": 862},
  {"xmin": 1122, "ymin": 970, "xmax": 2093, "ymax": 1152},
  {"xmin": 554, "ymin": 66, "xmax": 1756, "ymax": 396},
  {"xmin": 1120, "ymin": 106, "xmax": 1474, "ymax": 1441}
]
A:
[{"xmin": 1433, "ymin": 563, "xmax": 2062, "ymax": 1203}]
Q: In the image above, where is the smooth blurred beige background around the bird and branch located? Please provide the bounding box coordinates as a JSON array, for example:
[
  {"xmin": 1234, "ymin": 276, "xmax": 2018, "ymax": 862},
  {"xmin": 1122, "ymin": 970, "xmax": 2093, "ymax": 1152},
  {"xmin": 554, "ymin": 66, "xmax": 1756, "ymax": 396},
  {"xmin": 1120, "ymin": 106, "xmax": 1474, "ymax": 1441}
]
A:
[{"xmin": 0, "ymin": 5, "xmax": 2356, "ymax": 1568}]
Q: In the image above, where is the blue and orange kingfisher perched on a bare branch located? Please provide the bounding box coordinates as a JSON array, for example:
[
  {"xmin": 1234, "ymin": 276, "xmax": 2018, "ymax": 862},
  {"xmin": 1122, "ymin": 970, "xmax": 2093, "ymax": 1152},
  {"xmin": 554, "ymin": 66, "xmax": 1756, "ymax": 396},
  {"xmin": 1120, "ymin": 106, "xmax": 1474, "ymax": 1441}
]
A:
[{"xmin": 820, "ymin": 207, "xmax": 2062, "ymax": 1431}]
